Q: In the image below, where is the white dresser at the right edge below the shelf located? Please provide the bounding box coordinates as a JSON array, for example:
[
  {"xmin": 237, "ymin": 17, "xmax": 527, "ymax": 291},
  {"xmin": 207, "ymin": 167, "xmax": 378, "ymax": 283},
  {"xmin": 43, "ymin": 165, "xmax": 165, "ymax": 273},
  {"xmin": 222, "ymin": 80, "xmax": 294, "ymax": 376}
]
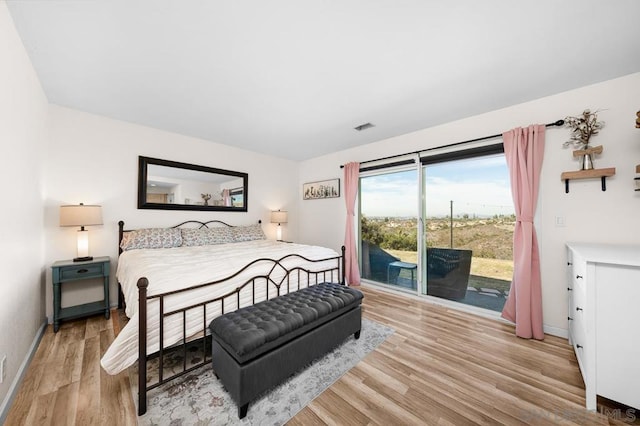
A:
[{"xmin": 567, "ymin": 243, "xmax": 640, "ymax": 410}]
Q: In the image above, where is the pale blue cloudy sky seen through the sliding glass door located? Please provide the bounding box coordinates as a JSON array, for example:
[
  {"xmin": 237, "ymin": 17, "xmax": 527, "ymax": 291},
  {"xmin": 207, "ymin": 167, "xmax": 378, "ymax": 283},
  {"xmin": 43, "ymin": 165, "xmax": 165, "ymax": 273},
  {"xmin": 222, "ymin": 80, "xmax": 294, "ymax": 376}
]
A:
[{"xmin": 361, "ymin": 155, "xmax": 514, "ymax": 217}]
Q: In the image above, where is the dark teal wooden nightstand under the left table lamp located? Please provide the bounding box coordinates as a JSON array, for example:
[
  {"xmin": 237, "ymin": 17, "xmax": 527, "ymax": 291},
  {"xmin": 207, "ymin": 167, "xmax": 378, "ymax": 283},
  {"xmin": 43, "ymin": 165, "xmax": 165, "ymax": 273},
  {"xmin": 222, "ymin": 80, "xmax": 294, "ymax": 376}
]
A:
[{"xmin": 51, "ymin": 256, "xmax": 110, "ymax": 332}]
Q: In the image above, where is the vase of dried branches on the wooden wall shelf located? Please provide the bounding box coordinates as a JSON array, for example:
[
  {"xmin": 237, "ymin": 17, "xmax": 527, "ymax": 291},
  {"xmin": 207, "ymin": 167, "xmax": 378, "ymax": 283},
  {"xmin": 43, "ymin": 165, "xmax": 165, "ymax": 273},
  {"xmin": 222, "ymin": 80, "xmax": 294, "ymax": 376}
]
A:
[{"xmin": 562, "ymin": 109, "xmax": 604, "ymax": 170}]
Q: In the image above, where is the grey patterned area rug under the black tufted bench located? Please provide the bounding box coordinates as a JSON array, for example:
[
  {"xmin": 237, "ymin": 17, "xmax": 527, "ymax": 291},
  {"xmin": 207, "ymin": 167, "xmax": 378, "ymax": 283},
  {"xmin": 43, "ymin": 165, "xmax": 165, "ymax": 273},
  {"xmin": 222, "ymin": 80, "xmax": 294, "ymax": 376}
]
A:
[{"xmin": 131, "ymin": 318, "xmax": 394, "ymax": 426}]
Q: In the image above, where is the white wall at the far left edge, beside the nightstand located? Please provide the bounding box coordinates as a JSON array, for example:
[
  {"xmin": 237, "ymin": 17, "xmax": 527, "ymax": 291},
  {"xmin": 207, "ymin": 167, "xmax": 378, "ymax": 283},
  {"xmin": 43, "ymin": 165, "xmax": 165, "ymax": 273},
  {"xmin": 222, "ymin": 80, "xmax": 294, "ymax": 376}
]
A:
[{"xmin": 0, "ymin": 2, "xmax": 47, "ymax": 412}]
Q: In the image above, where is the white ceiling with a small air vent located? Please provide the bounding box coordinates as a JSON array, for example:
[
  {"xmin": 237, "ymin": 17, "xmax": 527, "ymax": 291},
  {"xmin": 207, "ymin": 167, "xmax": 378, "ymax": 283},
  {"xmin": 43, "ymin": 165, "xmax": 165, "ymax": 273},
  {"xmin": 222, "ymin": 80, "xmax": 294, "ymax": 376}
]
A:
[{"xmin": 6, "ymin": 0, "xmax": 640, "ymax": 160}]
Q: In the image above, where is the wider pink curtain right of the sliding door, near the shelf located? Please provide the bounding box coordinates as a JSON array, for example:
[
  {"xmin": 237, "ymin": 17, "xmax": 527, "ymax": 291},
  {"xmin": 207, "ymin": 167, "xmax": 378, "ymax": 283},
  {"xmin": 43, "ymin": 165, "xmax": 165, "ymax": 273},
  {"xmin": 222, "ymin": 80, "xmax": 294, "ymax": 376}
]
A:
[{"xmin": 502, "ymin": 124, "xmax": 545, "ymax": 340}]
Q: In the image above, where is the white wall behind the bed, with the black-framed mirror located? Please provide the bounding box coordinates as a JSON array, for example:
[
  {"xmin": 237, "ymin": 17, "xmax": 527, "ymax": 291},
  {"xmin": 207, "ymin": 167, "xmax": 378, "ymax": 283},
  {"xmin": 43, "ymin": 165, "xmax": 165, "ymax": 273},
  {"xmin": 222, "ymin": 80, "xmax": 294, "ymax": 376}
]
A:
[{"xmin": 44, "ymin": 105, "xmax": 299, "ymax": 318}]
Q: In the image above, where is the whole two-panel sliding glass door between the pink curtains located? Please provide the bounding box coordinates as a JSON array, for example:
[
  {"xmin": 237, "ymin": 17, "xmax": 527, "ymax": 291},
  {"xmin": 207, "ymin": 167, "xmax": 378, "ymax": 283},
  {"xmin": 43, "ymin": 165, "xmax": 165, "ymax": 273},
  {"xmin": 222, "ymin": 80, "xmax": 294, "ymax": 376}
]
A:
[{"xmin": 359, "ymin": 144, "xmax": 515, "ymax": 311}]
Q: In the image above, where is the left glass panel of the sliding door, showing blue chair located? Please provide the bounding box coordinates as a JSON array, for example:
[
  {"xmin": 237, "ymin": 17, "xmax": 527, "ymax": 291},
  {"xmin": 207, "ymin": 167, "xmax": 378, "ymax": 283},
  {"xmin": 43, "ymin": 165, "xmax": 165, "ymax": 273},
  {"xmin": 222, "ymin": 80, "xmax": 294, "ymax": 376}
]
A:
[{"xmin": 359, "ymin": 165, "xmax": 419, "ymax": 291}]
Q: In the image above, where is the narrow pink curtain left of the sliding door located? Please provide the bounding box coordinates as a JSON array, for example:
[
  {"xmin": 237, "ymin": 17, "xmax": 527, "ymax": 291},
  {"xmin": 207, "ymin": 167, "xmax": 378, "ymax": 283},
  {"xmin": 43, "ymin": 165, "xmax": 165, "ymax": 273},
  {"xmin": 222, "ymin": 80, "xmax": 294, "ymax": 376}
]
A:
[{"xmin": 344, "ymin": 163, "xmax": 360, "ymax": 285}]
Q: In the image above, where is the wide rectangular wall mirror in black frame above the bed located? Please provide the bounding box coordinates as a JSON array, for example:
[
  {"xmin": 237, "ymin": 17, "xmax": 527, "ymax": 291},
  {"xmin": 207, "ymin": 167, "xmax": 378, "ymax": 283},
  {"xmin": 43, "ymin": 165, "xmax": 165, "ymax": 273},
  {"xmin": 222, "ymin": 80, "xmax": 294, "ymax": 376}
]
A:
[{"xmin": 138, "ymin": 156, "xmax": 249, "ymax": 212}]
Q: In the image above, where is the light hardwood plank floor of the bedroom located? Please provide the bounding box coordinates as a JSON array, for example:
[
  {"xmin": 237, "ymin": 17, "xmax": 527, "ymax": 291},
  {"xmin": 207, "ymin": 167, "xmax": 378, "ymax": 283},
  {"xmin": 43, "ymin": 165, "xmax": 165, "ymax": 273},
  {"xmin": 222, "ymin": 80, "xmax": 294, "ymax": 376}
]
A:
[{"xmin": 7, "ymin": 287, "xmax": 640, "ymax": 426}]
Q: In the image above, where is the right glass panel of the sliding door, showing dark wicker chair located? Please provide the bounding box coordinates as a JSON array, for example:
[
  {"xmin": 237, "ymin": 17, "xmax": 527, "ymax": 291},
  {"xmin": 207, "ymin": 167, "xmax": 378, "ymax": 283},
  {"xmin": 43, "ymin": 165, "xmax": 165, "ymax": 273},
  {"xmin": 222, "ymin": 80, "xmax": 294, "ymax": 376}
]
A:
[{"xmin": 421, "ymin": 152, "xmax": 515, "ymax": 311}]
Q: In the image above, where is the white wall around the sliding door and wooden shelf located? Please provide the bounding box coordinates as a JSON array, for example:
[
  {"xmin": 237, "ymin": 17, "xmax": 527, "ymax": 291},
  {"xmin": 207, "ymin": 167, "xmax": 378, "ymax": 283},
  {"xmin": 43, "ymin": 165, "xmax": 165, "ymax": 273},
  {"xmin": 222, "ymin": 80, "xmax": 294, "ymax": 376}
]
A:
[{"xmin": 298, "ymin": 73, "xmax": 640, "ymax": 329}]
